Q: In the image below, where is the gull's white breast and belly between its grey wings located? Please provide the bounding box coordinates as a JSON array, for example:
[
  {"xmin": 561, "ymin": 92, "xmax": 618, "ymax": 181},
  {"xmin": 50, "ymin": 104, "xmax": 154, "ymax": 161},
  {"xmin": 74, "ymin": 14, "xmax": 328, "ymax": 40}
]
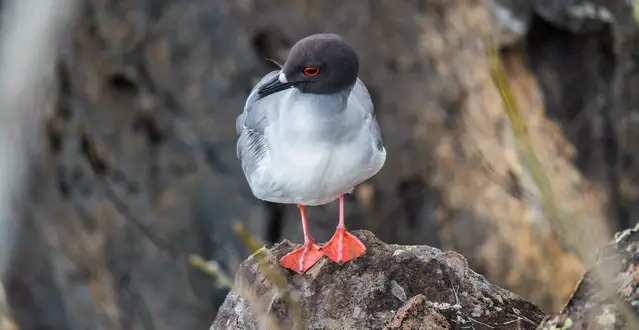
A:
[{"xmin": 251, "ymin": 90, "xmax": 385, "ymax": 205}]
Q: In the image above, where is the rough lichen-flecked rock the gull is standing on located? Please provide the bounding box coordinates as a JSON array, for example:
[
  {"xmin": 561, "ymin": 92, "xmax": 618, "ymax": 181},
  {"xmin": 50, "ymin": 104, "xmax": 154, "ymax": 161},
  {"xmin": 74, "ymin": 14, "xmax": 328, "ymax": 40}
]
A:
[{"xmin": 211, "ymin": 230, "xmax": 544, "ymax": 330}]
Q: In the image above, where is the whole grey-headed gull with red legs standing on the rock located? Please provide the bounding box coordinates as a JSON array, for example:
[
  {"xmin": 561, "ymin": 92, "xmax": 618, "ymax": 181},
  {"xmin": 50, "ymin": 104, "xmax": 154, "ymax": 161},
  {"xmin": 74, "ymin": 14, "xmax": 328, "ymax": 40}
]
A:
[{"xmin": 236, "ymin": 33, "xmax": 386, "ymax": 274}]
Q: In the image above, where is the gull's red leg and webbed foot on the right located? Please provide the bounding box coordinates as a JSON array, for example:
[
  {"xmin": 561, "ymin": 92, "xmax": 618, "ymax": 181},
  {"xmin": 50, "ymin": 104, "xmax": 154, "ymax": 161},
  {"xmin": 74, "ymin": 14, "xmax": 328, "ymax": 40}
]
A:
[{"xmin": 321, "ymin": 195, "xmax": 366, "ymax": 264}]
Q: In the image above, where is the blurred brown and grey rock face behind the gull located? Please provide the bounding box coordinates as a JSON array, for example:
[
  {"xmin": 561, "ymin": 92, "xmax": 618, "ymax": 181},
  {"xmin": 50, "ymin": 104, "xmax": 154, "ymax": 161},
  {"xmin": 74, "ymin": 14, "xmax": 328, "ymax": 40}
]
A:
[{"xmin": 5, "ymin": 0, "xmax": 639, "ymax": 330}]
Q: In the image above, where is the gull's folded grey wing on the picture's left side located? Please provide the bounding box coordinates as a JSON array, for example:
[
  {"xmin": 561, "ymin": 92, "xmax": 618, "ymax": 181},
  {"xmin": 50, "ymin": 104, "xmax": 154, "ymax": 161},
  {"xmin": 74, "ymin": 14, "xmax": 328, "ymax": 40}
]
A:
[{"xmin": 235, "ymin": 71, "xmax": 279, "ymax": 175}]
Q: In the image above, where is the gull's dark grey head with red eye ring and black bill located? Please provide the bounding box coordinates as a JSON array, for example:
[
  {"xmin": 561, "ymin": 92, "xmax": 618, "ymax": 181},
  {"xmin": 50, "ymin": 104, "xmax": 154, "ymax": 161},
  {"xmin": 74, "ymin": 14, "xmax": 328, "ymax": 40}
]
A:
[{"xmin": 258, "ymin": 33, "xmax": 359, "ymax": 97}]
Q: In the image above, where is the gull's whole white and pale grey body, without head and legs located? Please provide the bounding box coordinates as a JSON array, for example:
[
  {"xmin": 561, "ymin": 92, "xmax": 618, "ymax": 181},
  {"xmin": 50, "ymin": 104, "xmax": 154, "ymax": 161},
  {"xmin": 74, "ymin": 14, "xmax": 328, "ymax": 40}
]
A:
[{"xmin": 238, "ymin": 73, "xmax": 386, "ymax": 205}]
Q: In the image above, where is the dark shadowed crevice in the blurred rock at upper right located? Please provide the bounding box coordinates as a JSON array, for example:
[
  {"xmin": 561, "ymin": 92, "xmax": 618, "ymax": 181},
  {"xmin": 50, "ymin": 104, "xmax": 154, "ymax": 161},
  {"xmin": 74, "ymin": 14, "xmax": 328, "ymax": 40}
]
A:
[{"xmin": 525, "ymin": 16, "xmax": 632, "ymax": 229}]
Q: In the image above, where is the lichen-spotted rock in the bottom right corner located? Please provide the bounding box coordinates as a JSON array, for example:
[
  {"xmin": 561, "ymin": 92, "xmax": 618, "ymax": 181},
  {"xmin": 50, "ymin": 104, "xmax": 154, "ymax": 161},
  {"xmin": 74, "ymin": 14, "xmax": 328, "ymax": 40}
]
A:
[{"xmin": 542, "ymin": 225, "xmax": 639, "ymax": 330}]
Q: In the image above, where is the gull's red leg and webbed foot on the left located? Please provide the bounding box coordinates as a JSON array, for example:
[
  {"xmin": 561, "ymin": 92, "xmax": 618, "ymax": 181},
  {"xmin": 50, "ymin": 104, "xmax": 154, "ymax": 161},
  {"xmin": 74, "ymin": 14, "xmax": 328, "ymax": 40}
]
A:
[{"xmin": 280, "ymin": 205, "xmax": 323, "ymax": 274}]
